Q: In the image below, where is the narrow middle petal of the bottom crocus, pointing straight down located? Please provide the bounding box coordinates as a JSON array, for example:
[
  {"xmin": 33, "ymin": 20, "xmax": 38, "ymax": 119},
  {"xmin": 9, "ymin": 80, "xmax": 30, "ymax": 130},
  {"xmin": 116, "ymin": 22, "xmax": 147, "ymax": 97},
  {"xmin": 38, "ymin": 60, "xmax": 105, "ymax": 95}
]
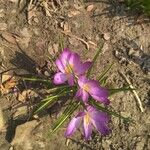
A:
[{"xmin": 83, "ymin": 114, "xmax": 92, "ymax": 140}]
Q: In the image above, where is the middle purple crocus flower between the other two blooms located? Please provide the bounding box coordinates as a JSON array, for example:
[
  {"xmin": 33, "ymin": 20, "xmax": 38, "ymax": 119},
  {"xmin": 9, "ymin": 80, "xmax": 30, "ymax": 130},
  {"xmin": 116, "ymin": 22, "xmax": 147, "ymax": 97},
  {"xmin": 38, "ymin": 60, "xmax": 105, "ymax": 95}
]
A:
[{"xmin": 76, "ymin": 76, "xmax": 110, "ymax": 105}]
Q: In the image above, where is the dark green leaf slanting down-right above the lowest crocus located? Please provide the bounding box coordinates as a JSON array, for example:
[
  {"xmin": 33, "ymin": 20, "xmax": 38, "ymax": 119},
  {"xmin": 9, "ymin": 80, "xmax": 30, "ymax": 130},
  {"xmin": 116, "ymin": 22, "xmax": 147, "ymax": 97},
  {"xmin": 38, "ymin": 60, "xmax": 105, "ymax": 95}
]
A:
[{"xmin": 89, "ymin": 99, "xmax": 134, "ymax": 123}]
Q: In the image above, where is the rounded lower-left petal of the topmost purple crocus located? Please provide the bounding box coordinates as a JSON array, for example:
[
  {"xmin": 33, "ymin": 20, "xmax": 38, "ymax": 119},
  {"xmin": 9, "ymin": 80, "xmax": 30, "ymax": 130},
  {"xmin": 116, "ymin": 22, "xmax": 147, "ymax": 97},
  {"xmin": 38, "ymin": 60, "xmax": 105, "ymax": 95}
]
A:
[{"xmin": 53, "ymin": 72, "xmax": 67, "ymax": 84}]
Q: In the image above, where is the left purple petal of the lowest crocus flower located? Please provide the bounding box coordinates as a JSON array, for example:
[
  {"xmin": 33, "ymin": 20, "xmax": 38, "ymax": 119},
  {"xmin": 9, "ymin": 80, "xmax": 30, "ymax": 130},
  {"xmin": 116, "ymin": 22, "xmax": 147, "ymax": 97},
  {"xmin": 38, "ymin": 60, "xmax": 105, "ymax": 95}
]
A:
[{"xmin": 65, "ymin": 117, "xmax": 82, "ymax": 137}]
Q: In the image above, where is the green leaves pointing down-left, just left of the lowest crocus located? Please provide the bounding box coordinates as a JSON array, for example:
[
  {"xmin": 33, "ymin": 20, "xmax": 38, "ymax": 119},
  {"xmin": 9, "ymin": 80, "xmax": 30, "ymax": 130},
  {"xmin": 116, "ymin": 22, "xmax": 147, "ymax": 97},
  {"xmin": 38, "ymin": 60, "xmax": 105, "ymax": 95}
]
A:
[{"xmin": 50, "ymin": 100, "xmax": 80, "ymax": 136}]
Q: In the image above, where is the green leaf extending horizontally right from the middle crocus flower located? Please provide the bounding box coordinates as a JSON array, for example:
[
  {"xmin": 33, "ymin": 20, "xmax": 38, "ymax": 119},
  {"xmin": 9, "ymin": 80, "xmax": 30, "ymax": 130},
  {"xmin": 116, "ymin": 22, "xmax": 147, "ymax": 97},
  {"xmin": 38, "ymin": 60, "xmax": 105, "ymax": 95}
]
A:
[{"xmin": 108, "ymin": 87, "xmax": 135, "ymax": 96}]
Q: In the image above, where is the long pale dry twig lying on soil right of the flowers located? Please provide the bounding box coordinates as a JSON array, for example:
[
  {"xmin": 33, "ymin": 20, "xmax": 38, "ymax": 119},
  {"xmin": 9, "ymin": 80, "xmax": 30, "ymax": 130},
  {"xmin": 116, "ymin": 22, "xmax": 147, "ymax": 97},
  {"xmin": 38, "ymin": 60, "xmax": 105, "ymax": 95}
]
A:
[{"xmin": 119, "ymin": 72, "xmax": 144, "ymax": 112}]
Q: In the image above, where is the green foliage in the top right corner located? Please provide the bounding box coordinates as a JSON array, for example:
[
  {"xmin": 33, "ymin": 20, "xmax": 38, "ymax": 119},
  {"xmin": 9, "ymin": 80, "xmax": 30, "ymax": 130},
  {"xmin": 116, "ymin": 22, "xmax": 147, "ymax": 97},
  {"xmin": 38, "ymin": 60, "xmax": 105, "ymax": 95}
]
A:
[{"xmin": 126, "ymin": 0, "xmax": 150, "ymax": 15}]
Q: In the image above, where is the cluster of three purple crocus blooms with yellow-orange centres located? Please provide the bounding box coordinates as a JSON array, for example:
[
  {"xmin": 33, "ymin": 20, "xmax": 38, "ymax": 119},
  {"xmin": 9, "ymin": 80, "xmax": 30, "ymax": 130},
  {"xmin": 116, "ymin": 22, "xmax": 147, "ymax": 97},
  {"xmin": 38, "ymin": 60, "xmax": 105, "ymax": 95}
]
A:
[{"xmin": 54, "ymin": 48, "xmax": 110, "ymax": 140}]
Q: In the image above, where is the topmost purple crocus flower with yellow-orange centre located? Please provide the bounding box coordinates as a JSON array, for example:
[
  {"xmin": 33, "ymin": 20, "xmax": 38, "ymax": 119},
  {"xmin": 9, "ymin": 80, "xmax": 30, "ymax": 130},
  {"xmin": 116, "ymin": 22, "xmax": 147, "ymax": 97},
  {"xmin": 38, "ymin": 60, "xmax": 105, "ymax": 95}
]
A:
[{"xmin": 54, "ymin": 48, "xmax": 91, "ymax": 85}]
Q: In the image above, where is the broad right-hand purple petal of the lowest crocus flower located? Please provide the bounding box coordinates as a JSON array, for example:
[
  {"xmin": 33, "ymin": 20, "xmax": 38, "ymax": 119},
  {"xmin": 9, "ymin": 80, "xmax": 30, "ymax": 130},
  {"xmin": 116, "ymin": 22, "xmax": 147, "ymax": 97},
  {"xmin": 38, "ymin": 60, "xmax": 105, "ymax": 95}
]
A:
[{"xmin": 90, "ymin": 111, "xmax": 110, "ymax": 135}]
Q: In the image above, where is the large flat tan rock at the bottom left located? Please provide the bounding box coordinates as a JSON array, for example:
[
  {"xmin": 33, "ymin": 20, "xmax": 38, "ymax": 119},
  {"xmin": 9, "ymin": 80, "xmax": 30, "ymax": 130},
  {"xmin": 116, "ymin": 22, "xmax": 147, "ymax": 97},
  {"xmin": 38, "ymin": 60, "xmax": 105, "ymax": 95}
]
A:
[{"xmin": 11, "ymin": 120, "xmax": 39, "ymax": 150}]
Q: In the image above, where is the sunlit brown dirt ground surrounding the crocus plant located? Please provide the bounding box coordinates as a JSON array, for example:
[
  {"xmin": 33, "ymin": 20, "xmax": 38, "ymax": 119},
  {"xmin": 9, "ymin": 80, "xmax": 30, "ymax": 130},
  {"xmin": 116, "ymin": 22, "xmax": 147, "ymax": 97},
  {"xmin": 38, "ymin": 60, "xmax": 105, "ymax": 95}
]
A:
[{"xmin": 0, "ymin": 0, "xmax": 150, "ymax": 150}]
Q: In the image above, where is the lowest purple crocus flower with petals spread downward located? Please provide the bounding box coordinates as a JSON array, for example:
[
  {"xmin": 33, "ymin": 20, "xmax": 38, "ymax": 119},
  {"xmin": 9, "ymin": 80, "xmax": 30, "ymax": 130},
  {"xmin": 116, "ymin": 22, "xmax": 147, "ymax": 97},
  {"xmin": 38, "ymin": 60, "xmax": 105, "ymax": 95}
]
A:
[{"xmin": 65, "ymin": 106, "xmax": 110, "ymax": 140}]
